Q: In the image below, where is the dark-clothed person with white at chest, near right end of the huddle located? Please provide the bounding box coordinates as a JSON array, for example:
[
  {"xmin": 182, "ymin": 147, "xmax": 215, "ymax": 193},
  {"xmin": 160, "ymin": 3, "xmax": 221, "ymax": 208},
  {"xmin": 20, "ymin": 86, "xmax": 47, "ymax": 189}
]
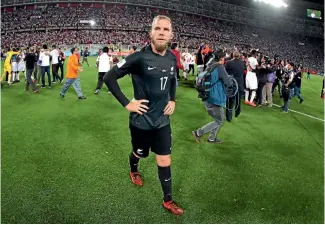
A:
[{"xmin": 282, "ymin": 63, "xmax": 295, "ymax": 113}]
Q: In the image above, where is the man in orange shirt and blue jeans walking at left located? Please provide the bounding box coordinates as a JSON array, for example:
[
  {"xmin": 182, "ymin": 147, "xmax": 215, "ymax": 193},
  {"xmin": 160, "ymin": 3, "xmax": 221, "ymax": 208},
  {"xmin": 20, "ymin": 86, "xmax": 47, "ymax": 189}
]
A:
[{"xmin": 60, "ymin": 47, "xmax": 86, "ymax": 99}]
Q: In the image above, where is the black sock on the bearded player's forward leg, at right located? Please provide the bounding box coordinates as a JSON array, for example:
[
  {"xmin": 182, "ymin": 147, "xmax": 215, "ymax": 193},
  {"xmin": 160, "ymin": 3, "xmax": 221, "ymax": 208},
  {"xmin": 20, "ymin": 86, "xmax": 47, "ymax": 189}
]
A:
[{"xmin": 158, "ymin": 166, "xmax": 172, "ymax": 202}]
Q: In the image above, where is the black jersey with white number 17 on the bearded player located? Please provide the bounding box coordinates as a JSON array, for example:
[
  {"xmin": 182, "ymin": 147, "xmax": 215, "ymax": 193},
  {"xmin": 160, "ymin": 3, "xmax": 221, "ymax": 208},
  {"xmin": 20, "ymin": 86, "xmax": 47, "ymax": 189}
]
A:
[{"xmin": 104, "ymin": 46, "xmax": 177, "ymax": 130}]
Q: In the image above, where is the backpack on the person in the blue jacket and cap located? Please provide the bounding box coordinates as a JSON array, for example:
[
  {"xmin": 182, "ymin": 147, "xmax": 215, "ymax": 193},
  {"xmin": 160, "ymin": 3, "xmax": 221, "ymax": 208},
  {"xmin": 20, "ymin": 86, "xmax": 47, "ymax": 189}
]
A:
[{"xmin": 195, "ymin": 63, "xmax": 218, "ymax": 101}]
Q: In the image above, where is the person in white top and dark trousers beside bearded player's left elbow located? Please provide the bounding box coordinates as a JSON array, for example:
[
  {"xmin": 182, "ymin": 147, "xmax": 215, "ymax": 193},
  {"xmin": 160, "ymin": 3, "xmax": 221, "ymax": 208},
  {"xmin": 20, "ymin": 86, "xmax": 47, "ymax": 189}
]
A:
[{"xmin": 95, "ymin": 47, "xmax": 113, "ymax": 95}]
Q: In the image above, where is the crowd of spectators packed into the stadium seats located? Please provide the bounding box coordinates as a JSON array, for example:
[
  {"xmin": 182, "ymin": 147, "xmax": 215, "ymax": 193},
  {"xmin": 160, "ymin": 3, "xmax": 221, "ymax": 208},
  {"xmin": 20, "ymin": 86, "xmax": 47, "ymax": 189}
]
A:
[{"xmin": 1, "ymin": 5, "xmax": 324, "ymax": 70}]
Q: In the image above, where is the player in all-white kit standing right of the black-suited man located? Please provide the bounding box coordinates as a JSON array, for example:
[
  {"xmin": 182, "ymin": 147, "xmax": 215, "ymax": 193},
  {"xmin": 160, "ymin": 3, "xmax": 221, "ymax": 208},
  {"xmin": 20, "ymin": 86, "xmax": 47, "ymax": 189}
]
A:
[{"xmin": 245, "ymin": 50, "xmax": 258, "ymax": 107}]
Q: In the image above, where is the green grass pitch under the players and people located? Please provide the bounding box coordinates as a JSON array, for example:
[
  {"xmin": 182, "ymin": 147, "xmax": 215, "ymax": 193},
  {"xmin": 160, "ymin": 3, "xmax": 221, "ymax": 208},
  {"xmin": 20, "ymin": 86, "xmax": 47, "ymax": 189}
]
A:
[{"xmin": 1, "ymin": 59, "xmax": 324, "ymax": 223}]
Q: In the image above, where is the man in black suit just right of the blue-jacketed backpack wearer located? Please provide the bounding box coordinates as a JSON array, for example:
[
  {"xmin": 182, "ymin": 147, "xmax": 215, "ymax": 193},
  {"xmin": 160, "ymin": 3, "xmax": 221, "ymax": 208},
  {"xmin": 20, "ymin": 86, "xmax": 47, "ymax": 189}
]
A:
[{"xmin": 225, "ymin": 51, "xmax": 245, "ymax": 122}]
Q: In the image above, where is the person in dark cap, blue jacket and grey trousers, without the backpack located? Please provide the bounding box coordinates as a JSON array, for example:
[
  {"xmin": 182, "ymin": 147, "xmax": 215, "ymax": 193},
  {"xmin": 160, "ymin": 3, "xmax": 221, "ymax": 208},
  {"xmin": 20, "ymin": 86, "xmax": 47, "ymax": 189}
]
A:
[{"xmin": 192, "ymin": 50, "xmax": 233, "ymax": 144}]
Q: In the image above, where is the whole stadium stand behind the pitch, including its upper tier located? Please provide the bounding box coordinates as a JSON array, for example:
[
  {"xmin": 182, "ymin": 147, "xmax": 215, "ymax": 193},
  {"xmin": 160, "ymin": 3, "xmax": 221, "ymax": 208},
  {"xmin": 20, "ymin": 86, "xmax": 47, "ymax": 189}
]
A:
[{"xmin": 1, "ymin": 0, "xmax": 324, "ymax": 70}]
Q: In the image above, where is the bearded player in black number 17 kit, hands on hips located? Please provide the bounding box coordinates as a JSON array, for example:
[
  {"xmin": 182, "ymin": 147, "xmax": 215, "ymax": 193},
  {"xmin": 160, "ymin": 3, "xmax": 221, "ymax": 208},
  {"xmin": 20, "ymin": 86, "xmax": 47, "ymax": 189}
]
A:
[{"xmin": 104, "ymin": 15, "xmax": 183, "ymax": 215}]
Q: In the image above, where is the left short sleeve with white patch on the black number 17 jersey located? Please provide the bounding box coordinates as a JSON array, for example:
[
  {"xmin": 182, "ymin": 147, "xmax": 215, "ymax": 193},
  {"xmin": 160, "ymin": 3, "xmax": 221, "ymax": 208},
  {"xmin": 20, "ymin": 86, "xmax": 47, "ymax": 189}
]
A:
[{"xmin": 114, "ymin": 52, "xmax": 141, "ymax": 78}]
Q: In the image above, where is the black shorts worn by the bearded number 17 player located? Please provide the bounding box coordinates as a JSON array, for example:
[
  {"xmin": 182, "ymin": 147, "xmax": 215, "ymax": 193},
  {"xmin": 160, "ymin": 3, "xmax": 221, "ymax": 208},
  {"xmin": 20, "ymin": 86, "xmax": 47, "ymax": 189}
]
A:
[{"xmin": 130, "ymin": 124, "xmax": 172, "ymax": 158}]
